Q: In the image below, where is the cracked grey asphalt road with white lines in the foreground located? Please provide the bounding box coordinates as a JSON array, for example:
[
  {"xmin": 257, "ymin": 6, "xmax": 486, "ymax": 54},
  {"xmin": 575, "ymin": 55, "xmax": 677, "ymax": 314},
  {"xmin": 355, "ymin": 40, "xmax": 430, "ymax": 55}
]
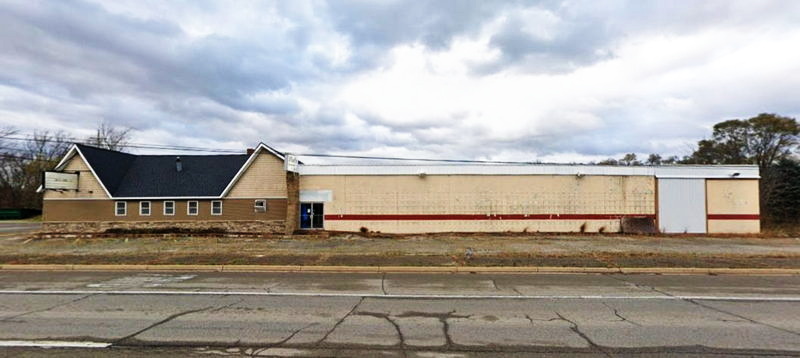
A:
[{"xmin": 0, "ymin": 272, "xmax": 800, "ymax": 357}]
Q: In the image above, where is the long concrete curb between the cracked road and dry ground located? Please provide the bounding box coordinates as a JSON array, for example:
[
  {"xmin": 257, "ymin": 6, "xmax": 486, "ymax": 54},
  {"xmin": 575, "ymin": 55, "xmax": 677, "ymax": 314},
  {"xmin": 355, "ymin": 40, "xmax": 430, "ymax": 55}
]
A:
[{"xmin": 0, "ymin": 264, "xmax": 800, "ymax": 275}]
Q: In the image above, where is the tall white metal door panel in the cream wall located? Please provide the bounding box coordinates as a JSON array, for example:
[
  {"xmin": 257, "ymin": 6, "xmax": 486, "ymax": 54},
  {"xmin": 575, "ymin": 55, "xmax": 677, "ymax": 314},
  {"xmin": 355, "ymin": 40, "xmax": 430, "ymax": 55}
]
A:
[{"xmin": 658, "ymin": 178, "xmax": 706, "ymax": 234}]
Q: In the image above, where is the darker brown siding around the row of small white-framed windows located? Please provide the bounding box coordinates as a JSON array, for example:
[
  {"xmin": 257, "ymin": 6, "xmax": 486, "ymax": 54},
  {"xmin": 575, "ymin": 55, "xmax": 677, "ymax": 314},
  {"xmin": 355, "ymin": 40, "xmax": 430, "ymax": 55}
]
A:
[{"xmin": 43, "ymin": 199, "xmax": 286, "ymax": 221}]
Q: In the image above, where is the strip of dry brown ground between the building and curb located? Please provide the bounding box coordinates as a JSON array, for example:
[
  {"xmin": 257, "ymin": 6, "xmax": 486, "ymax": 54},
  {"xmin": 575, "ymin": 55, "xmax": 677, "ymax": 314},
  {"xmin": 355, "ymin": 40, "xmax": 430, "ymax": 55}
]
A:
[{"xmin": 0, "ymin": 233, "xmax": 800, "ymax": 268}]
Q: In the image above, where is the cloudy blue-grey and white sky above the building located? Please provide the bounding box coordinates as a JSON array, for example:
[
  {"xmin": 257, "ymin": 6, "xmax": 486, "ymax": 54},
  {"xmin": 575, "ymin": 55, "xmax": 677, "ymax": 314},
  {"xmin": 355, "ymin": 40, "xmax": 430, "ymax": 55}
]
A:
[{"xmin": 0, "ymin": 0, "xmax": 800, "ymax": 162}]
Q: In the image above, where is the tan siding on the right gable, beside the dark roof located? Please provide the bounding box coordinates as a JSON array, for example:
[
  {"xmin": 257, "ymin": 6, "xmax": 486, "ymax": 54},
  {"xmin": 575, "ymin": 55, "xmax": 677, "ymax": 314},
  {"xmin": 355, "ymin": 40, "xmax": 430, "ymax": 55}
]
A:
[{"xmin": 227, "ymin": 150, "xmax": 286, "ymax": 198}]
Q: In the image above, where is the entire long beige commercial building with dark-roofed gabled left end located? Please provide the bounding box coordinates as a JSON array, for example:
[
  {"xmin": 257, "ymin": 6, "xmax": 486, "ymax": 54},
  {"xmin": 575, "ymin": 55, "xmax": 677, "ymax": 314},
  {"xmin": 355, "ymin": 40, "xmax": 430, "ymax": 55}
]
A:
[{"xmin": 43, "ymin": 144, "xmax": 760, "ymax": 233}]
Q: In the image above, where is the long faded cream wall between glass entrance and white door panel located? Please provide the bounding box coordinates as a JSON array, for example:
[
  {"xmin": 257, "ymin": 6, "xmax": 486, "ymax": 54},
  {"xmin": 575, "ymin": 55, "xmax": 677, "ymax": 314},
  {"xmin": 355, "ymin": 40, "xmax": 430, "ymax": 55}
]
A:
[{"xmin": 300, "ymin": 175, "xmax": 655, "ymax": 232}]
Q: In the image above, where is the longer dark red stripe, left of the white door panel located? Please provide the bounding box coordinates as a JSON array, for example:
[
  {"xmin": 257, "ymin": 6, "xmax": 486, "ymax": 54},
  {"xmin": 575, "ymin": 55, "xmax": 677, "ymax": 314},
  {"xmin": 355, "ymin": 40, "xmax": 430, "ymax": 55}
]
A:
[{"xmin": 325, "ymin": 214, "xmax": 656, "ymax": 221}]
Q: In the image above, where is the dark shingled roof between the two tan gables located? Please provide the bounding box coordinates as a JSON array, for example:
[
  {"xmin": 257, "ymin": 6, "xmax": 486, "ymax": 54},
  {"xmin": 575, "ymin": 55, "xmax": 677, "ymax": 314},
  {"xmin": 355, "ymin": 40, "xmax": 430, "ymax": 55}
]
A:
[{"xmin": 77, "ymin": 144, "xmax": 248, "ymax": 197}]
